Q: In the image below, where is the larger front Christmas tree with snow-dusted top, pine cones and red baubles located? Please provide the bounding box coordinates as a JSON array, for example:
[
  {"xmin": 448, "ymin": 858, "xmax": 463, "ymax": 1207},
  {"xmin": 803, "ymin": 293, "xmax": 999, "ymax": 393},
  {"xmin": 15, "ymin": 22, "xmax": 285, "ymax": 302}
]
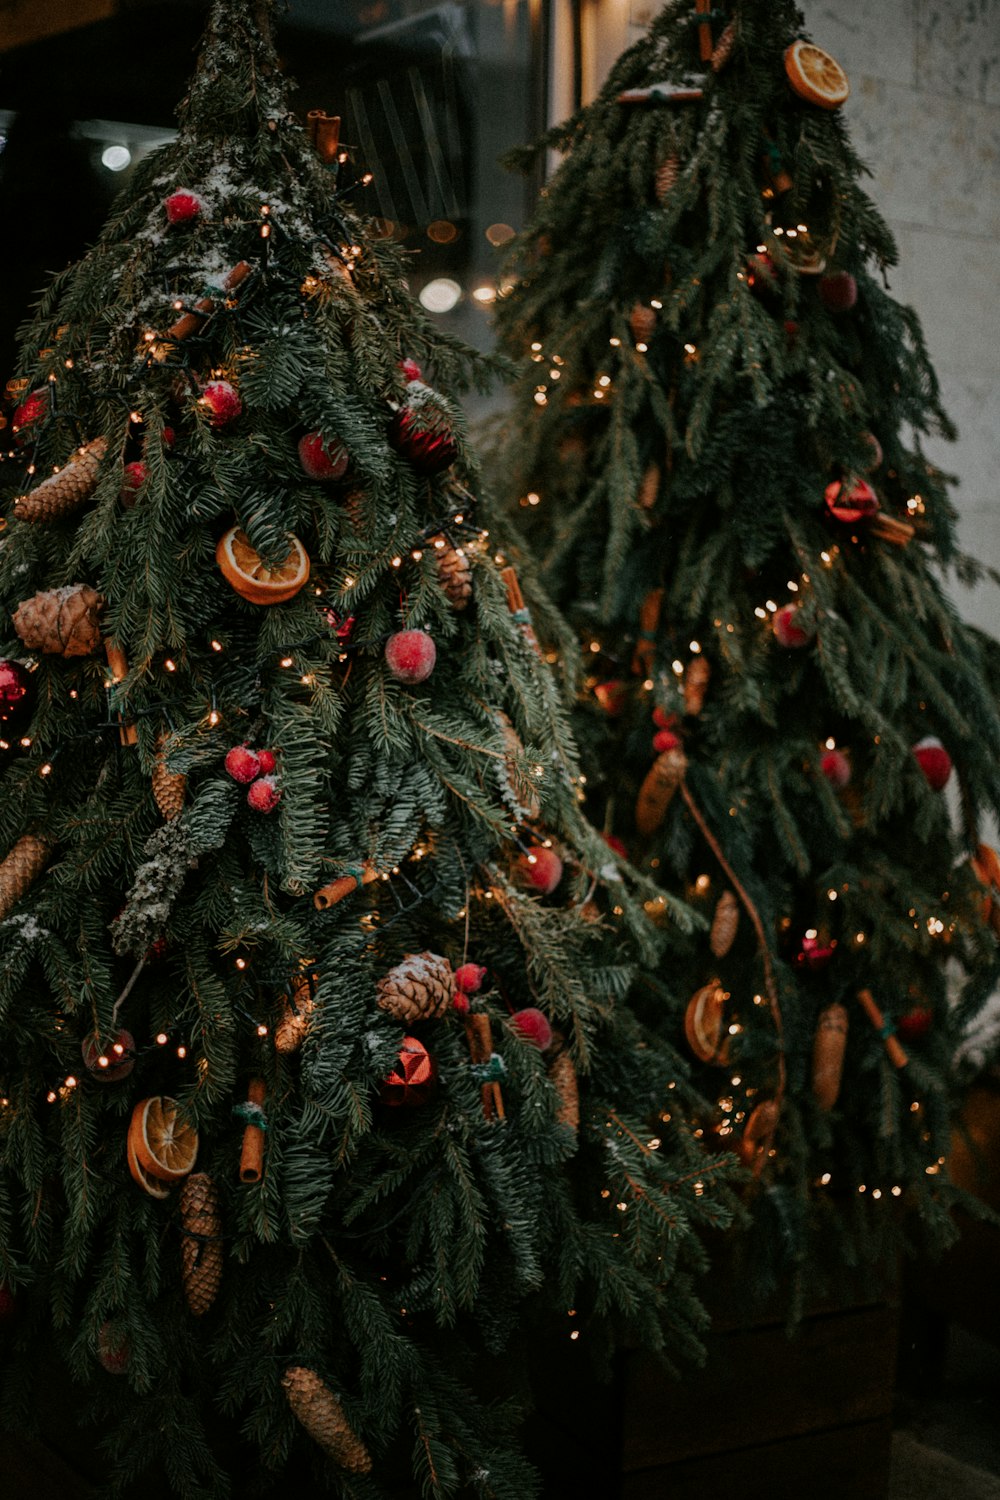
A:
[{"xmin": 0, "ymin": 0, "xmax": 740, "ymax": 1500}]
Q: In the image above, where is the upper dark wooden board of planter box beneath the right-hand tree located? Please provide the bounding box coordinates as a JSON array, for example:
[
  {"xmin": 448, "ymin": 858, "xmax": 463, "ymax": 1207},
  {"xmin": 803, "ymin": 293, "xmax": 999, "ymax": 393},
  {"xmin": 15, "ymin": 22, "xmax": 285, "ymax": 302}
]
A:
[{"xmin": 622, "ymin": 1305, "xmax": 898, "ymax": 1464}]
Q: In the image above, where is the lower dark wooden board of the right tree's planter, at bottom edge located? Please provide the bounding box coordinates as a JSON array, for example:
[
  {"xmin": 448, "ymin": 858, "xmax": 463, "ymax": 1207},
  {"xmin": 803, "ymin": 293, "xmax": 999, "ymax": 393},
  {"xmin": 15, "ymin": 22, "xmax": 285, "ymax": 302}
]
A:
[{"xmin": 619, "ymin": 1418, "xmax": 892, "ymax": 1500}]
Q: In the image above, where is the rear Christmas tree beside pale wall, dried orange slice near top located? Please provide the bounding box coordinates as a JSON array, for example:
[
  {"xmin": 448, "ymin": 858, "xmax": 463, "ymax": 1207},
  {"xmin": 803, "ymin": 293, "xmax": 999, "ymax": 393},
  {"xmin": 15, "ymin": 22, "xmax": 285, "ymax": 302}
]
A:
[{"xmin": 498, "ymin": 0, "xmax": 1000, "ymax": 1290}]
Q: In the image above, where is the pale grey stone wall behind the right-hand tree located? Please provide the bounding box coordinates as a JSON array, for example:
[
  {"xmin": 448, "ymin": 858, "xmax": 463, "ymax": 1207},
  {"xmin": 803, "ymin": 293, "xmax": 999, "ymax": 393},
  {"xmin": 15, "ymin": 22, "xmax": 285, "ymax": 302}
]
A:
[{"xmin": 607, "ymin": 0, "xmax": 1000, "ymax": 636}]
